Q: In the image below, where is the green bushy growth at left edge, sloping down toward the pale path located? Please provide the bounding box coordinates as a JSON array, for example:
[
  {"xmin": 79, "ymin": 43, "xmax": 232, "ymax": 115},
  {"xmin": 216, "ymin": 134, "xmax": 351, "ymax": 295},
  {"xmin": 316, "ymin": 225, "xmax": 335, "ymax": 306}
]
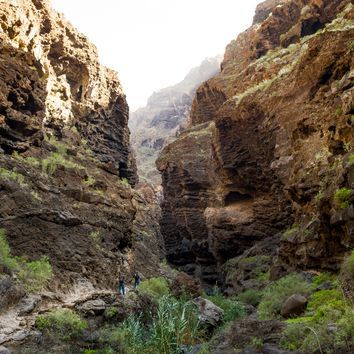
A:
[{"xmin": 0, "ymin": 229, "xmax": 53, "ymax": 293}]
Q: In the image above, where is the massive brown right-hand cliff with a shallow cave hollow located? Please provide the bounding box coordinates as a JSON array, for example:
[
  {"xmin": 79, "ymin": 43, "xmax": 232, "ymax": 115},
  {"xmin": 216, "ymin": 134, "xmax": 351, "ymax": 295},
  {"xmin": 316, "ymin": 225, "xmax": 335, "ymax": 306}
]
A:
[{"xmin": 157, "ymin": 0, "xmax": 354, "ymax": 287}]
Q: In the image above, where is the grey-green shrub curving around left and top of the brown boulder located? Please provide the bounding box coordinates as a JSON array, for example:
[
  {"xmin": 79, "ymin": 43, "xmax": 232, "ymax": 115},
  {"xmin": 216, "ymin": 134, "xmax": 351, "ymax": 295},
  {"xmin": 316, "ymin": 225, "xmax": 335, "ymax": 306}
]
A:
[{"xmin": 258, "ymin": 273, "xmax": 310, "ymax": 319}]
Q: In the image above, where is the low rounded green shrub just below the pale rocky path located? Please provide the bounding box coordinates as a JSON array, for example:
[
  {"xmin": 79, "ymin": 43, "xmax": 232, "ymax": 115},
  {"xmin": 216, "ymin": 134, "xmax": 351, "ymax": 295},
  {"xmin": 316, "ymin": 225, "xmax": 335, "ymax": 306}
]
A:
[{"xmin": 35, "ymin": 309, "xmax": 87, "ymax": 341}]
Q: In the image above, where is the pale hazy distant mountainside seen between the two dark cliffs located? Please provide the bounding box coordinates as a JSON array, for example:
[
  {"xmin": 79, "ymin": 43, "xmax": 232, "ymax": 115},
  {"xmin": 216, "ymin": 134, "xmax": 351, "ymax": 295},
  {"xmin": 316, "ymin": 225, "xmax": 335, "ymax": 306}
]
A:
[{"xmin": 129, "ymin": 57, "xmax": 220, "ymax": 185}]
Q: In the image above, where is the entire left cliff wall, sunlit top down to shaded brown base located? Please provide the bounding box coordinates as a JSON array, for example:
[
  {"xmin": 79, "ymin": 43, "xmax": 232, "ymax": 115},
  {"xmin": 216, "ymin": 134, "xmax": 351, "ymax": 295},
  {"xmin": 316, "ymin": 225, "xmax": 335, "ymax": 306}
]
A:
[{"xmin": 0, "ymin": 0, "xmax": 162, "ymax": 287}]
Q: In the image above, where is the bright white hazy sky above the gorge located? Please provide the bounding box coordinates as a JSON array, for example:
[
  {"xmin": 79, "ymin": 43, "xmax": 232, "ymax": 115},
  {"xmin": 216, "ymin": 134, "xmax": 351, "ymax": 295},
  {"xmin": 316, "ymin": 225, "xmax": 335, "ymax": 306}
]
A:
[{"xmin": 52, "ymin": 0, "xmax": 261, "ymax": 110}]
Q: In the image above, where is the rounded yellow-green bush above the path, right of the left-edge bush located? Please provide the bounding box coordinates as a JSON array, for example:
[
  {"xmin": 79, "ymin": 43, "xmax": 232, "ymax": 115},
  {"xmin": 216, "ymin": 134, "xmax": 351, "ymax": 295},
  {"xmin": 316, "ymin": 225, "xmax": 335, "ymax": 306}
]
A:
[{"xmin": 18, "ymin": 256, "xmax": 53, "ymax": 293}]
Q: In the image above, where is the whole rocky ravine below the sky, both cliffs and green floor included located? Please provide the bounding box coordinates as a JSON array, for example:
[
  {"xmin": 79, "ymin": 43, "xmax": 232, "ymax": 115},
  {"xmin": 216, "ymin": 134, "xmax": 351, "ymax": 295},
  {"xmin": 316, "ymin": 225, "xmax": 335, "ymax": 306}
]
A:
[{"xmin": 0, "ymin": 0, "xmax": 354, "ymax": 354}]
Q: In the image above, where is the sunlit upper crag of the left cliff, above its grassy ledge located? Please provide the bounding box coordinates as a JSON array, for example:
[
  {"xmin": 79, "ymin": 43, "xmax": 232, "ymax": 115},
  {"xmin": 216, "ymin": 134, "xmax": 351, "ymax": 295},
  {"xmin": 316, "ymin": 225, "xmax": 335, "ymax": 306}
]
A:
[{"xmin": 0, "ymin": 0, "xmax": 136, "ymax": 184}]
